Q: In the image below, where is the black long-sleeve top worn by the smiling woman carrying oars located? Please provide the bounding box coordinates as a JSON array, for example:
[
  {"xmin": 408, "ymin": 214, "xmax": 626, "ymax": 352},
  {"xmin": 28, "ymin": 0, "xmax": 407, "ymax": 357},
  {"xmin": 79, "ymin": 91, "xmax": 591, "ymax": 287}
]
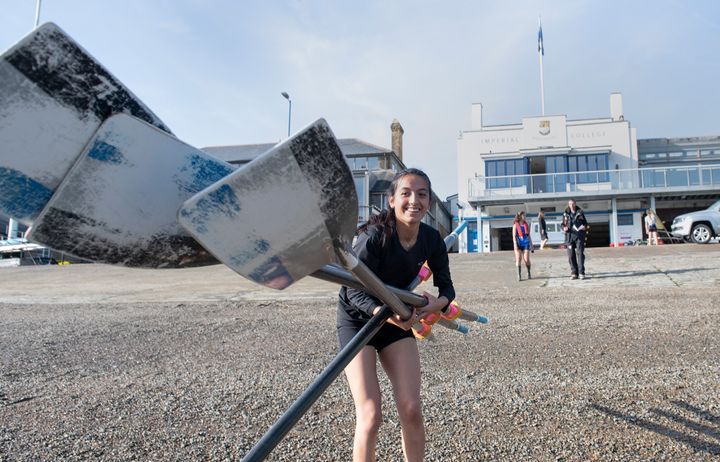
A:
[{"xmin": 338, "ymin": 223, "xmax": 455, "ymax": 326}]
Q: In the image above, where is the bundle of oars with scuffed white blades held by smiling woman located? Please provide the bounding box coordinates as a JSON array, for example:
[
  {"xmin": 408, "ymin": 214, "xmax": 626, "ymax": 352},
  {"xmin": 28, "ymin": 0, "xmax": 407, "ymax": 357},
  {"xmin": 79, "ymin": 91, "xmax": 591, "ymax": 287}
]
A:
[{"xmin": 0, "ymin": 23, "xmax": 487, "ymax": 461}]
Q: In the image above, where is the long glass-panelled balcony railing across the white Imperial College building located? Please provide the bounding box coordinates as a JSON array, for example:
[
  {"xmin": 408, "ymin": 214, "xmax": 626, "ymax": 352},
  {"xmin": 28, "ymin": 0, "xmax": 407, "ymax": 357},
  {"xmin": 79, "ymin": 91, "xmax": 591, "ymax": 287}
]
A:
[{"xmin": 468, "ymin": 164, "xmax": 720, "ymax": 199}]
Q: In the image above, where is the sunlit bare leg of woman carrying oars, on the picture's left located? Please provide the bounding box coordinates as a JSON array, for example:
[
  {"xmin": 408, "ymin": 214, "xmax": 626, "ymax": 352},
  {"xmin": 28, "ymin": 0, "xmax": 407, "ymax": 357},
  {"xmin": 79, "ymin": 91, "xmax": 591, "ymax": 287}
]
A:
[{"xmin": 345, "ymin": 346, "xmax": 382, "ymax": 462}]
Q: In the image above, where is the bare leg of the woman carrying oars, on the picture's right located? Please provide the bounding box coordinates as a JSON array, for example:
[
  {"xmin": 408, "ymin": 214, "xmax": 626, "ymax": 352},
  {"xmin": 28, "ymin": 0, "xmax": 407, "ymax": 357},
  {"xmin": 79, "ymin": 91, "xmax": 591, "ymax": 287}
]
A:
[{"xmin": 380, "ymin": 338, "xmax": 425, "ymax": 462}]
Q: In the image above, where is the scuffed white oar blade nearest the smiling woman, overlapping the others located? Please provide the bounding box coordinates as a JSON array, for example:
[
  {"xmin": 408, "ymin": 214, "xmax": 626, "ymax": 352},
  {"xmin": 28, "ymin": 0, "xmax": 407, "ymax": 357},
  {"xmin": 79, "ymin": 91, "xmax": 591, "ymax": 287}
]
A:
[{"xmin": 178, "ymin": 119, "xmax": 357, "ymax": 289}]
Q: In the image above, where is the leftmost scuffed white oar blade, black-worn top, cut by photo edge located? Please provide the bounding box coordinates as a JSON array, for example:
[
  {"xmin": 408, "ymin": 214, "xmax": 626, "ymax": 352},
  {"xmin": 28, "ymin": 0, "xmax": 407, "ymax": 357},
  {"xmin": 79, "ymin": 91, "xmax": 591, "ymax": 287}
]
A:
[{"xmin": 0, "ymin": 23, "xmax": 169, "ymax": 225}]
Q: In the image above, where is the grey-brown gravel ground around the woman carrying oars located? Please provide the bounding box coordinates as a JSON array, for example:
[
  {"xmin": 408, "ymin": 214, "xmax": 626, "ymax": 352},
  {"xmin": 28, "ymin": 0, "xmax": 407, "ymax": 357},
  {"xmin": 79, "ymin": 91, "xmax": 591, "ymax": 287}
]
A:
[{"xmin": 0, "ymin": 251, "xmax": 720, "ymax": 461}]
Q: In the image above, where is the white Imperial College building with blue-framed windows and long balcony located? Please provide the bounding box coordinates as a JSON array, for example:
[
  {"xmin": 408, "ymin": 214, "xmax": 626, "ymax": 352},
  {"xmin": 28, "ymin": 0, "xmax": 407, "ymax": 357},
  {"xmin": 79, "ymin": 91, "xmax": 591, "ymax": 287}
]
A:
[{"xmin": 457, "ymin": 93, "xmax": 720, "ymax": 252}]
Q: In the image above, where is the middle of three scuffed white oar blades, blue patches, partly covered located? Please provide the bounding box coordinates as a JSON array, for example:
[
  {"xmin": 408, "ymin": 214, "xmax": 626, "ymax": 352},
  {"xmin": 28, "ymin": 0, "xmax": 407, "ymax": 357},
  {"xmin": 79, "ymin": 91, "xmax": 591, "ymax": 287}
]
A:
[{"xmin": 28, "ymin": 114, "xmax": 234, "ymax": 268}]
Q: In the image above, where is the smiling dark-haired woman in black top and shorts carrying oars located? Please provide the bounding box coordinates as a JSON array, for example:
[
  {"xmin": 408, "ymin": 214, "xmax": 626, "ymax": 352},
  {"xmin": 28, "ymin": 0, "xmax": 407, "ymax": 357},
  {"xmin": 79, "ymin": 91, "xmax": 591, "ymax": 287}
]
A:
[{"xmin": 337, "ymin": 168, "xmax": 455, "ymax": 462}]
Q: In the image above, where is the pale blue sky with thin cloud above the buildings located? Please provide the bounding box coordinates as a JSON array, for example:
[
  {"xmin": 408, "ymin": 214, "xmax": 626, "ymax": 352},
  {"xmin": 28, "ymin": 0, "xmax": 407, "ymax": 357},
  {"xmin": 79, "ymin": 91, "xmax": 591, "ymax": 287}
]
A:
[{"xmin": 0, "ymin": 0, "xmax": 720, "ymax": 198}]
